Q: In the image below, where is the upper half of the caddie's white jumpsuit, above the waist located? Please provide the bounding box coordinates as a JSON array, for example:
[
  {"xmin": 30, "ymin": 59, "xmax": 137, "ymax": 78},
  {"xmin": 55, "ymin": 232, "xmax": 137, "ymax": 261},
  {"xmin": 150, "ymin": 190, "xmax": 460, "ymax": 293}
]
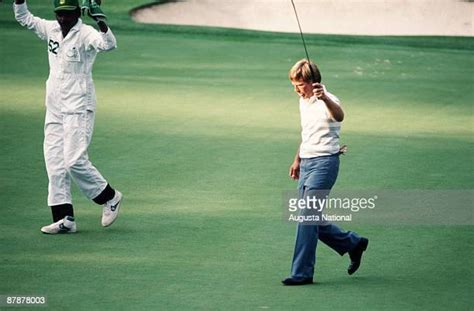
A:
[{"xmin": 13, "ymin": 3, "xmax": 116, "ymax": 113}]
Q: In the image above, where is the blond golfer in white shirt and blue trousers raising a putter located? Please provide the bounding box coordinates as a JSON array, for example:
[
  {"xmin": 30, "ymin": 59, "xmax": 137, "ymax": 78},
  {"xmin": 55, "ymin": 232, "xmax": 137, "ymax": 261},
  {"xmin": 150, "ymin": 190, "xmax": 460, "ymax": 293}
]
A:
[{"xmin": 282, "ymin": 59, "xmax": 369, "ymax": 285}]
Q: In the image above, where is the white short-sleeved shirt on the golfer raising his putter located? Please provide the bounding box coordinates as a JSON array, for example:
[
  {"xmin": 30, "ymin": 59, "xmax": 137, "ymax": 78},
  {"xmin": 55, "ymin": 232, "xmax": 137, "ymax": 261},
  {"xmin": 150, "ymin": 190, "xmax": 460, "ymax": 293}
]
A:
[{"xmin": 300, "ymin": 92, "xmax": 341, "ymax": 158}]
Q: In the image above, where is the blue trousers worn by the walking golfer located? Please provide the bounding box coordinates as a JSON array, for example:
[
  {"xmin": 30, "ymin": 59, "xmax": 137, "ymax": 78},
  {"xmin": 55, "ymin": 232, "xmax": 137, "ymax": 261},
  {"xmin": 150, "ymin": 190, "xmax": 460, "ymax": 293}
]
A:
[{"xmin": 291, "ymin": 155, "xmax": 360, "ymax": 279}]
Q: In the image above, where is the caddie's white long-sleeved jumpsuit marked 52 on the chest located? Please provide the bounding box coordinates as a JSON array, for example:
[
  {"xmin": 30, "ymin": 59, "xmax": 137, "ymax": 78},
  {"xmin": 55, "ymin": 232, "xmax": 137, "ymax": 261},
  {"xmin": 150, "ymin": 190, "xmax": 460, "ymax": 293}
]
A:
[{"xmin": 13, "ymin": 3, "xmax": 116, "ymax": 206}]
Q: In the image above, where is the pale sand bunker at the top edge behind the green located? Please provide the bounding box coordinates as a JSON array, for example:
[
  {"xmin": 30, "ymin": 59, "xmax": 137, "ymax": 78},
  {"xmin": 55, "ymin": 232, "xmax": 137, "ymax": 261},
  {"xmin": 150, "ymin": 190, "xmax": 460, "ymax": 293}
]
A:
[{"xmin": 132, "ymin": 0, "xmax": 474, "ymax": 36}]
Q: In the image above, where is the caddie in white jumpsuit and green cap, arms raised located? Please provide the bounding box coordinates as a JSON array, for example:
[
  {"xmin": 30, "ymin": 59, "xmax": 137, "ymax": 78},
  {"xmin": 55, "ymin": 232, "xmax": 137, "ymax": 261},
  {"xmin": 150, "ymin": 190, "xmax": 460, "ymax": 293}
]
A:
[{"xmin": 13, "ymin": 0, "xmax": 122, "ymax": 234}]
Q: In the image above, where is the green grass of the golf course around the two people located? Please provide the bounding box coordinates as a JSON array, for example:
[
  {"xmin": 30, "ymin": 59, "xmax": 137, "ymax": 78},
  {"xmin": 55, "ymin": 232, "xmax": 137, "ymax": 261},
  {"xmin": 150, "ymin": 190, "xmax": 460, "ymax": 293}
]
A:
[{"xmin": 0, "ymin": 0, "xmax": 474, "ymax": 310}]
